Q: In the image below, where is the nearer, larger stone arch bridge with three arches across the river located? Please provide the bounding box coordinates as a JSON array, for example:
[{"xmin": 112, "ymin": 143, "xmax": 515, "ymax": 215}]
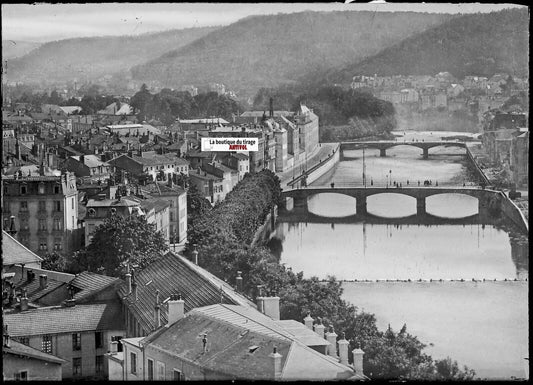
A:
[{"xmin": 281, "ymin": 186, "xmax": 502, "ymax": 216}]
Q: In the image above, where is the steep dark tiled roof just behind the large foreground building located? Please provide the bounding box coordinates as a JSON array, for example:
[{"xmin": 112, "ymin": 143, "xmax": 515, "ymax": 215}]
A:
[{"xmin": 119, "ymin": 252, "xmax": 255, "ymax": 331}]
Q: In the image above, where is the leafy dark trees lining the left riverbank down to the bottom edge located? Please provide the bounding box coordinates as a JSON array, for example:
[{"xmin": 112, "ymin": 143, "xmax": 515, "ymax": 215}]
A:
[{"xmin": 182, "ymin": 170, "xmax": 475, "ymax": 380}]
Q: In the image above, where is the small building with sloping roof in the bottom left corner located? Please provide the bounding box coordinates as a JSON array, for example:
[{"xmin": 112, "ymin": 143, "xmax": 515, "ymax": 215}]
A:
[{"xmin": 2, "ymin": 327, "xmax": 66, "ymax": 381}]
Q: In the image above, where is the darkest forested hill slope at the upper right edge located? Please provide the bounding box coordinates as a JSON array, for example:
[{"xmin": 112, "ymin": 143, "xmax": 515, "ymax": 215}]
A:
[{"xmin": 307, "ymin": 8, "xmax": 529, "ymax": 85}]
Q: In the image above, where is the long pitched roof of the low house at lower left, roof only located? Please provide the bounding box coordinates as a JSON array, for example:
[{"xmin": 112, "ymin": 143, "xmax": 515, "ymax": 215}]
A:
[{"xmin": 4, "ymin": 302, "xmax": 123, "ymax": 337}]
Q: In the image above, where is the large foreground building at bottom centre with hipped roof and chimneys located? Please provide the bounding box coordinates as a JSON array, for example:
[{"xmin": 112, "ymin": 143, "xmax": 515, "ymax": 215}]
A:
[{"xmin": 110, "ymin": 302, "xmax": 366, "ymax": 381}]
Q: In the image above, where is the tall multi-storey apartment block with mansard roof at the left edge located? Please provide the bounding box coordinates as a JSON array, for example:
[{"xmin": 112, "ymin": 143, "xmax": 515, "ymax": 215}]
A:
[{"xmin": 2, "ymin": 172, "xmax": 82, "ymax": 255}]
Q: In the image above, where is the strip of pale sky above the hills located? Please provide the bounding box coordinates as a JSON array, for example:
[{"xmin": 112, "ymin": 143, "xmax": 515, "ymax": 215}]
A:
[{"xmin": 2, "ymin": 1, "xmax": 519, "ymax": 43}]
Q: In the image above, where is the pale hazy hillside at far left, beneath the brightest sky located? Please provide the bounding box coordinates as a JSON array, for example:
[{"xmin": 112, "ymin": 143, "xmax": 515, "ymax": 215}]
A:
[{"xmin": 9, "ymin": 27, "xmax": 218, "ymax": 81}]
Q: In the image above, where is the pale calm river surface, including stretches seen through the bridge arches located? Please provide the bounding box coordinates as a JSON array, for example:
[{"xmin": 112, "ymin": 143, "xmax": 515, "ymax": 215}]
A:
[{"xmin": 272, "ymin": 132, "xmax": 529, "ymax": 379}]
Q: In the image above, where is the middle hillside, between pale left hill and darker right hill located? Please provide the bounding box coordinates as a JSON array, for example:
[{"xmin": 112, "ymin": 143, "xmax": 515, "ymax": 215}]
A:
[{"xmin": 132, "ymin": 11, "xmax": 451, "ymax": 95}]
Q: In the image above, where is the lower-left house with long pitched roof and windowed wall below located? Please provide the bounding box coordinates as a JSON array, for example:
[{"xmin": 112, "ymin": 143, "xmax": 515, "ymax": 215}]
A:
[{"xmin": 3, "ymin": 302, "xmax": 124, "ymax": 379}]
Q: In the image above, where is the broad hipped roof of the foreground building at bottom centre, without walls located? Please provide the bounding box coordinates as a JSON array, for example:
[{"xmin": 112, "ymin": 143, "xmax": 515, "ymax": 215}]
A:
[{"xmin": 142, "ymin": 304, "xmax": 355, "ymax": 380}]
